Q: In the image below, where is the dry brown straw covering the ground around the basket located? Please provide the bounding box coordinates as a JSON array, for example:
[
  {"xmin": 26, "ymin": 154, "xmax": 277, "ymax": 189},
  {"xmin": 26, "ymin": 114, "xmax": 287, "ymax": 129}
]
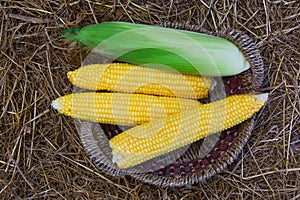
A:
[{"xmin": 0, "ymin": 0, "xmax": 300, "ymax": 199}]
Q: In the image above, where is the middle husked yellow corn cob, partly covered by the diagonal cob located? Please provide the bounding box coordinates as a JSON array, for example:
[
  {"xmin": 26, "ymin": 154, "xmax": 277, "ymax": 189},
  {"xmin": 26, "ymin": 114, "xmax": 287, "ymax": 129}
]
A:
[{"xmin": 52, "ymin": 92, "xmax": 200, "ymax": 126}]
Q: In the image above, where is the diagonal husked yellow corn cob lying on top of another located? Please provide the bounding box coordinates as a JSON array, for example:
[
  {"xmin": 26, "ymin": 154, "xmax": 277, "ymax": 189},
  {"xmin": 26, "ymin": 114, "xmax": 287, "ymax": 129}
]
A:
[{"xmin": 109, "ymin": 94, "xmax": 267, "ymax": 168}]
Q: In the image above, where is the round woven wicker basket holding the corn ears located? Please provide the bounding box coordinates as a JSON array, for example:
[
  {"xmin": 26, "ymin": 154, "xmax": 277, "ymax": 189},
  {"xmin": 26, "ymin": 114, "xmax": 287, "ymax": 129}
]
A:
[{"xmin": 76, "ymin": 23, "xmax": 263, "ymax": 186}]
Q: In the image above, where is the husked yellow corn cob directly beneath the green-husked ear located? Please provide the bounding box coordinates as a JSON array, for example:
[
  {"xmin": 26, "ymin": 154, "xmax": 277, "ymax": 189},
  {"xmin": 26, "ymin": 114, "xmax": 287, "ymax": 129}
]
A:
[{"xmin": 68, "ymin": 63, "xmax": 211, "ymax": 99}]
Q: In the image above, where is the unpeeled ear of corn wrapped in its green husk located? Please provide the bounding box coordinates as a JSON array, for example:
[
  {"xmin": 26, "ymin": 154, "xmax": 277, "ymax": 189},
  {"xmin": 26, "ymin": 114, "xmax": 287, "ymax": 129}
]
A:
[{"xmin": 64, "ymin": 22, "xmax": 250, "ymax": 76}]
